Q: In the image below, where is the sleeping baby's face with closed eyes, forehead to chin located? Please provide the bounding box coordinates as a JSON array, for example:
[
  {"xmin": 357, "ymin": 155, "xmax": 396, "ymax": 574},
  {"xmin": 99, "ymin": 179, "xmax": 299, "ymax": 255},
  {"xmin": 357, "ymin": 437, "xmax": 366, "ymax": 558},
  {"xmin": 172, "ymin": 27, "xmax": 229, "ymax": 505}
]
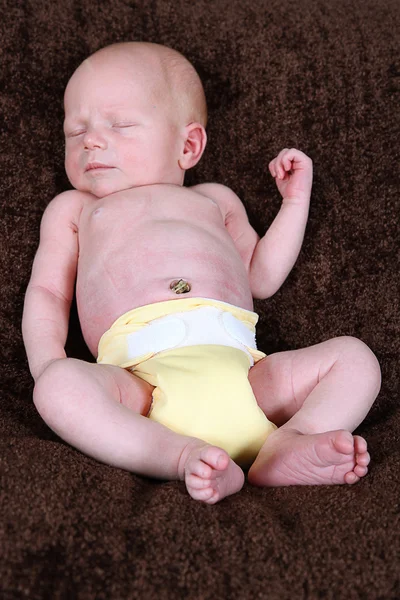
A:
[{"xmin": 64, "ymin": 60, "xmax": 183, "ymax": 198}]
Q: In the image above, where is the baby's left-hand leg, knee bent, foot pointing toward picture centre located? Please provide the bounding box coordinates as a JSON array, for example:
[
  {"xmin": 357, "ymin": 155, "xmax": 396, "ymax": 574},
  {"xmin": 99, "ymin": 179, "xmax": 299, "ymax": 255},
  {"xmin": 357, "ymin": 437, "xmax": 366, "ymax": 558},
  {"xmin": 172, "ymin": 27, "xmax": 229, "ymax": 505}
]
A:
[{"xmin": 34, "ymin": 358, "xmax": 244, "ymax": 503}]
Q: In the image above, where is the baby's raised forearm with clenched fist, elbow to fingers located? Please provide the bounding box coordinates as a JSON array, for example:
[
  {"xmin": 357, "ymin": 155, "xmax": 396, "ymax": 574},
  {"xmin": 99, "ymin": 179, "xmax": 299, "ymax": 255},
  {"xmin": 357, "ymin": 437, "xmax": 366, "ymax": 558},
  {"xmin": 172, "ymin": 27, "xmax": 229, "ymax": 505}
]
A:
[{"xmin": 250, "ymin": 148, "xmax": 312, "ymax": 299}]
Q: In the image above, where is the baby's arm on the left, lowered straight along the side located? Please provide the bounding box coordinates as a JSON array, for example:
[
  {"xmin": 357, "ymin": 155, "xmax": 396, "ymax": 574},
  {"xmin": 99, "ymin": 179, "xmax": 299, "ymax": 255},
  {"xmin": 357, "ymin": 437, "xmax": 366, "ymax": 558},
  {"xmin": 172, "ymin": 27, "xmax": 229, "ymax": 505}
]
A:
[{"xmin": 22, "ymin": 190, "xmax": 83, "ymax": 381}]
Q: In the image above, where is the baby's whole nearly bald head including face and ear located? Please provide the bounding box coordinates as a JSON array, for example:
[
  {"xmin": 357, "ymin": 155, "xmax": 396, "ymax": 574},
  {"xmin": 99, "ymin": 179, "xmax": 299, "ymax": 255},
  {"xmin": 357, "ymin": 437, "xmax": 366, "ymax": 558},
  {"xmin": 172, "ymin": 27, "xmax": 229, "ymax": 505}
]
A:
[{"xmin": 64, "ymin": 42, "xmax": 207, "ymax": 198}]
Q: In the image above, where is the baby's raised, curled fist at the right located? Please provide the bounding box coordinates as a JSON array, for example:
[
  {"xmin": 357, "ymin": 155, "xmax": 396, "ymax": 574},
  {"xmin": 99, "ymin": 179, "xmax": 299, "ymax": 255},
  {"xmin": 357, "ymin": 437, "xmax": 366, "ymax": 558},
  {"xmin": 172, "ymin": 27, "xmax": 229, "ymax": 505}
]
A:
[{"xmin": 269, "ymin": 148, "xmax": 313, "ymax": 202}]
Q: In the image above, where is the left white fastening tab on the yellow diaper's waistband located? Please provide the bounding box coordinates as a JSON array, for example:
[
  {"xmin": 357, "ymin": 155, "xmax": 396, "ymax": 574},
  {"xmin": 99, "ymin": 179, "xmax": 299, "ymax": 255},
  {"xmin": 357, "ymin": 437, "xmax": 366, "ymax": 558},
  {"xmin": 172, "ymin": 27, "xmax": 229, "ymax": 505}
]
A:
[{"xmin": 126, "ymin": 316, "xmax": 186, "ymax": 359}]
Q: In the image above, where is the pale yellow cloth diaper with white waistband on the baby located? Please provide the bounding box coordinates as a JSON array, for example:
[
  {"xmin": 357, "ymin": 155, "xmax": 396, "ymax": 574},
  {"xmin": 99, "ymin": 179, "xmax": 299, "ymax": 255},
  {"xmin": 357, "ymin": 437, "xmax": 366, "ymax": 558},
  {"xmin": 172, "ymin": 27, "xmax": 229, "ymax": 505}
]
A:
[{"xmin": 97, "ymin": 298, "xmax": 276, "ymax": 467}]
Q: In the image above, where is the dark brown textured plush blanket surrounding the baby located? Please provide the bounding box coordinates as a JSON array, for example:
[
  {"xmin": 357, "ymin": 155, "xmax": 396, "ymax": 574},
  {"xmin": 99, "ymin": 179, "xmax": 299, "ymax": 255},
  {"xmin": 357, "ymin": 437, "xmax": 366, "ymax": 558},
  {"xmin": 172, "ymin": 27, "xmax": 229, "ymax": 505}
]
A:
[{"xmin": 0, "ymin": 0, "xmax": 400, "ymax": 600}]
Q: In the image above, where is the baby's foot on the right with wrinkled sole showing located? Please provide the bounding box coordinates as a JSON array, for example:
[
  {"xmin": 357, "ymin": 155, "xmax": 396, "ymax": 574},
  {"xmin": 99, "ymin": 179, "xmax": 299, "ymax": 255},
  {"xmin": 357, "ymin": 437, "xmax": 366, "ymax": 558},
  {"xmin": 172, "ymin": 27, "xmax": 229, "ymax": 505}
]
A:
[{"xmin": 248, "ymin": 429, "xmax": 370, "ymax": 486}]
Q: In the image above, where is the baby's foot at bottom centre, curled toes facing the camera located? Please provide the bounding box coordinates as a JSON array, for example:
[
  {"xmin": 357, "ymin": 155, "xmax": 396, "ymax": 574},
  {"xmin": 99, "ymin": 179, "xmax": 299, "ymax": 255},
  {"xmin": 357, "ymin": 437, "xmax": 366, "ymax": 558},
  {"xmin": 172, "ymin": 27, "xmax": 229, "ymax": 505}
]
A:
[{"xmin": 183, "ymin": 443, "xmax": 244, "ymax": 504}]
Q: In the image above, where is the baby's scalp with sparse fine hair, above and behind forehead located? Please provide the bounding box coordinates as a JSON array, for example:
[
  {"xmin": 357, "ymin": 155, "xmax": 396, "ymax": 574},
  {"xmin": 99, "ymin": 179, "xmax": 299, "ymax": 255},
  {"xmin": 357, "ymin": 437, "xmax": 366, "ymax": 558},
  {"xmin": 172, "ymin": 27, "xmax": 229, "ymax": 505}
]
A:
[{"xmin": 78, "ymin": 42, "xmax": 207, "ymax": 127}]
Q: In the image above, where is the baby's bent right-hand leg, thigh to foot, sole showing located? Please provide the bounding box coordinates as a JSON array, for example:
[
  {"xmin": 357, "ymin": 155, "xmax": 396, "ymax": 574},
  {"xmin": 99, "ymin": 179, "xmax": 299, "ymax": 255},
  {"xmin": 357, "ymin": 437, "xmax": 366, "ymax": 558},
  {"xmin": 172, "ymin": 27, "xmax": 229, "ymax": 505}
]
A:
[{"xmin": 249, "ymin": 337, "xmax": 381, "ymax": 485}]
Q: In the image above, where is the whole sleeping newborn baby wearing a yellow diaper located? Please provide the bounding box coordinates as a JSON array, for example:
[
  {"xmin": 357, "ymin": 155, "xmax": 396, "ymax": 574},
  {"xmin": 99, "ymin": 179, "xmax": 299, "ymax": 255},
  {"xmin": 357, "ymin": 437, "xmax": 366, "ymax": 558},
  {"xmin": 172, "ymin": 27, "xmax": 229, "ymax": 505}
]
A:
[{"xmin": 22, "ymin": 42, "xmax": 380, "ymax": 504}]
